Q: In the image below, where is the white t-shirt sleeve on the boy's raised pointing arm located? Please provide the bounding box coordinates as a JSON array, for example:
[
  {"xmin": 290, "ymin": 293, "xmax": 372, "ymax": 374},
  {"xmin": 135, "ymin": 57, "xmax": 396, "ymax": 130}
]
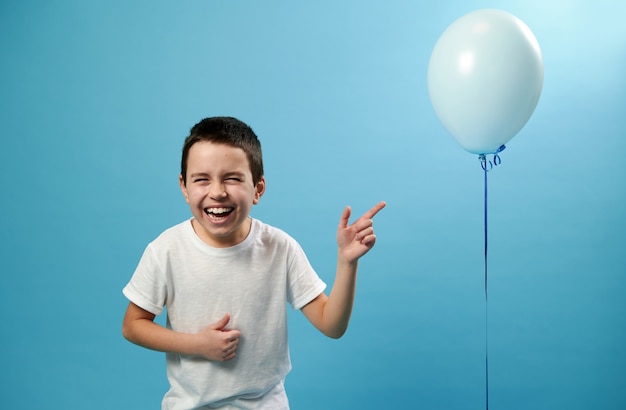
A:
[{"xmin": 287, "ymin": 240, "xmax": 326, "ymax": 310}]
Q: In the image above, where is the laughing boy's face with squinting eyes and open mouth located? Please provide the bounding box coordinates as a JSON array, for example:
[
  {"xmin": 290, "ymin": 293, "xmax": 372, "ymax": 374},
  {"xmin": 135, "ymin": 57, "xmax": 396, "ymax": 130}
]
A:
[{"xmin": 179, "ymin": 141, "xmax": 265, "ymax": 248}]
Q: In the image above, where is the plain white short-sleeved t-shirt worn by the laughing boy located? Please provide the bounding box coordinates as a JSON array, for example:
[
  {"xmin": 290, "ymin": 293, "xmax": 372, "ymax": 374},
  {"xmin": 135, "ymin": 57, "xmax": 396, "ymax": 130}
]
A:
[{"xmin": 123, "ymin": 219, "xmax": 326, "ymax": 410}]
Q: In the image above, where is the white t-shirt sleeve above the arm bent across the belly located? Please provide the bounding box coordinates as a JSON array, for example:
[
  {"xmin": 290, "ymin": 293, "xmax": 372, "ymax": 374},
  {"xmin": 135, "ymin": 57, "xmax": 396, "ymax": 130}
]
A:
[{"xmin": 122, "ymin": 245, "xmax": 167, "ymax": 316}]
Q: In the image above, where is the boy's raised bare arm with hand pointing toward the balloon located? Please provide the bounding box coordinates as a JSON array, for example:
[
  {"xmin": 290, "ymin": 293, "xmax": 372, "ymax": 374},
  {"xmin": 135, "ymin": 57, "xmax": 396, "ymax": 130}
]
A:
[{"xmin": 302, "ymin": 202, "xmax": 386, "ymax": 339}]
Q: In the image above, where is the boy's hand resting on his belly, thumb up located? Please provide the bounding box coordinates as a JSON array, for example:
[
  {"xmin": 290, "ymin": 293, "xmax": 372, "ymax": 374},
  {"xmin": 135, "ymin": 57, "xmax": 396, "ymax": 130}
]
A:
[{"xmin": 198, "ymin": 313, "xmax": 241, "ymax": 362}]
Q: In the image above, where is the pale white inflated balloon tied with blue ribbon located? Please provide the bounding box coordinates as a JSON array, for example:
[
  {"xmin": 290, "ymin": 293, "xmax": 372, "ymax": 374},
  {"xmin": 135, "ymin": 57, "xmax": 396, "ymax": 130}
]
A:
[{"xmin": 428, "ymin": 9, "xmax": 543, "ymax": 154}]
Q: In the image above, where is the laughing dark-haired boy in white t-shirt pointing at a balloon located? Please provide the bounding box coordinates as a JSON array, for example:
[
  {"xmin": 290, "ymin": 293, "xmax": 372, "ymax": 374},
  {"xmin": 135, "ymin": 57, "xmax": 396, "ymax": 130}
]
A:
[{"xmin": 122, "ymin": 117, "xmax": 385, "ymax": 410}]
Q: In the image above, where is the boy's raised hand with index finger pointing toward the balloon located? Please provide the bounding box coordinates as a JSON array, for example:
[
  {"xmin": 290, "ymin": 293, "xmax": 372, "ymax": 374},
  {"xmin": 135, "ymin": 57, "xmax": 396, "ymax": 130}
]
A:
[{"xmin": 337, "ymin": 201, "xmax": 387, "ymax": 263}]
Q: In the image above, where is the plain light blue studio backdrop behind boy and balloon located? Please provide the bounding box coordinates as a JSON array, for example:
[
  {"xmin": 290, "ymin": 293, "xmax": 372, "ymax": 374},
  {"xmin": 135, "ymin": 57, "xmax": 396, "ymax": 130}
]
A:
[{"xmin": 0, "ymin": 0, "xmax": 626, "ymax": 410}]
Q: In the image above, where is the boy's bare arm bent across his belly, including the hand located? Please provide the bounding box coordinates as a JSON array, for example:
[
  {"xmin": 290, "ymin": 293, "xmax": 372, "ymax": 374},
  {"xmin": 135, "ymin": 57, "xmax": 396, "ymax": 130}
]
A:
[{"xmin": 122, "ymin": 302, "xmax": 240, "ymax": 361}]
